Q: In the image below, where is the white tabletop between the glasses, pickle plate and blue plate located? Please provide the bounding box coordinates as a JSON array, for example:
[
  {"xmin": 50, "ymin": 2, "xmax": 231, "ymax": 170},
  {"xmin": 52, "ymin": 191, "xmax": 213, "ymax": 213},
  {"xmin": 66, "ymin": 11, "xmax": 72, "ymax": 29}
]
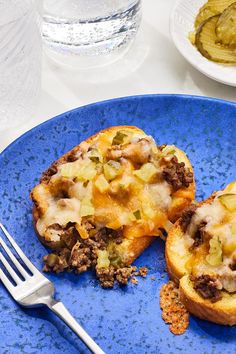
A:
[{"xmin": 0, "ymin": 0, "xmax": 236, "ymax": 152}]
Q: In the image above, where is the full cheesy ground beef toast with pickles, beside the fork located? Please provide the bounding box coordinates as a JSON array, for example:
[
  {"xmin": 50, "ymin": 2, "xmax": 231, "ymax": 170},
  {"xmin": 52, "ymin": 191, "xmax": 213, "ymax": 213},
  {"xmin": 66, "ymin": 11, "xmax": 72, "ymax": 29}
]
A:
[{"xmin": 31, "ymin": 126, "xmax": 195, "ymax": 287}]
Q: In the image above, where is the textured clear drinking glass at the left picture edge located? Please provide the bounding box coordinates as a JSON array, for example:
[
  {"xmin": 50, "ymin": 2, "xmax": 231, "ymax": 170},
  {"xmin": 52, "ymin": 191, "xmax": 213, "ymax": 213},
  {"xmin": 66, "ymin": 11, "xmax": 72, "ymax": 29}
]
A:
[{"xmin": 0, "ymin": 0, "xmax": 42, "ymax": 130}]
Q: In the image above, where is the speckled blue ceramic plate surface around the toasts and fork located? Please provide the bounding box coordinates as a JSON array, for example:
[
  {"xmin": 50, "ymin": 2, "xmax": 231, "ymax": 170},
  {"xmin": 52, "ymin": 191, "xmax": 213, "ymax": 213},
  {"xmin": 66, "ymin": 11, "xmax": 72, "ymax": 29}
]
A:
[{"xmin": 0, "ymin": 95, "xmax": 236, "ymax": 354}]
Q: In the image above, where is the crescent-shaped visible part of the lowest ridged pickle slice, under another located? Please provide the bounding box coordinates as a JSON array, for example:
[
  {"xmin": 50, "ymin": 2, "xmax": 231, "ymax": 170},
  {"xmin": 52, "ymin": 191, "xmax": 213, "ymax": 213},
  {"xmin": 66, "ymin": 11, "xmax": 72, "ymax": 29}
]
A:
[{"xmin": 196, "ymin": 15, "xmax": 236, "ymax": 65}]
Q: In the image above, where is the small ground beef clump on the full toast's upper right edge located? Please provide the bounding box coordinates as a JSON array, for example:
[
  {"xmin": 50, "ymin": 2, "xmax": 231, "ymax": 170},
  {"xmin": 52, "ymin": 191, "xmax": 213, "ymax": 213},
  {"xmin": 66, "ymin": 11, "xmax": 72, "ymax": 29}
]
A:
[{"xmin": 162, "ymin": 156, "xmax": 193, "ymax": 191}]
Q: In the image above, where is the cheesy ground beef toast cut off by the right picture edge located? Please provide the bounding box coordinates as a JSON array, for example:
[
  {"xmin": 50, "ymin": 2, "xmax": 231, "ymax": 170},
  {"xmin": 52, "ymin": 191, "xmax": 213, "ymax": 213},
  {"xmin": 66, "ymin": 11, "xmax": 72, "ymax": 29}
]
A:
[{"xmin": 166, "ymin": 182, "xmax": 236, "ymax": 325}]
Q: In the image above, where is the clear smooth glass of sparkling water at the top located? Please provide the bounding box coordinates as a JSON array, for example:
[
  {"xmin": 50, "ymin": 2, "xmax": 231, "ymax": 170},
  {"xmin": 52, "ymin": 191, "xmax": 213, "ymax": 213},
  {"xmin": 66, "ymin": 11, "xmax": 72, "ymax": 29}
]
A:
[{"xmin": 42, "ymin": 0, "xmax": 141, "ymax": 63}]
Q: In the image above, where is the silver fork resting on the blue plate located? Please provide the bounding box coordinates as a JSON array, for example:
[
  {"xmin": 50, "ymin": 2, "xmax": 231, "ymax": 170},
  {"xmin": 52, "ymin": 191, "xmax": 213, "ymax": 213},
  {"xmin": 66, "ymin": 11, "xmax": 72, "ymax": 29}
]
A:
[{"xmin": 0, "ymin": 223, "xmax": 105, "ymax": 354}]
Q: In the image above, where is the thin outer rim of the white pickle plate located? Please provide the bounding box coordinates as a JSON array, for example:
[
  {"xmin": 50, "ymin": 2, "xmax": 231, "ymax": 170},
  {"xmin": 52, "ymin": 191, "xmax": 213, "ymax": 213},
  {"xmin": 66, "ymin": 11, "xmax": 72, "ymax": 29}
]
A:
[{"xmin": 169, "ymin": 0, "xmax": 236, "ymax": 87}]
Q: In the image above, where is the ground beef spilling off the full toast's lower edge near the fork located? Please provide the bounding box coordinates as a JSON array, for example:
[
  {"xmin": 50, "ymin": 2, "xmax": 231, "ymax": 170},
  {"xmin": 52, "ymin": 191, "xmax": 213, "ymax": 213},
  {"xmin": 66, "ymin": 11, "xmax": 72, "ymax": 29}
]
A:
[{"xmin": 44, "ymin": 227, "xmax": 132, "ymax": 288}]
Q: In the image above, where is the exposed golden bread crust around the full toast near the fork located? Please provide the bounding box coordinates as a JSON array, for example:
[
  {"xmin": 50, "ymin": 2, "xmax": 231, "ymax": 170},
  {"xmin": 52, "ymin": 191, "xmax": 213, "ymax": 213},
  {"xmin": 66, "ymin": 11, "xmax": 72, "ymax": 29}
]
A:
[{"xmin": 31, "ymin": 126, "xmax": 195, "ymax": 264}]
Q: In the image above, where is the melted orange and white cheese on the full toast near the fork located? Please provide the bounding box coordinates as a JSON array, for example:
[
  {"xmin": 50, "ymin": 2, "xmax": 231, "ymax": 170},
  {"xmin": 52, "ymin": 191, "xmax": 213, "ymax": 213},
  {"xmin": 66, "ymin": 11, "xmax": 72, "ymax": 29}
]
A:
[{"xmin": 33, "ymin": 128, "xmax": 186, "ymax": 239}]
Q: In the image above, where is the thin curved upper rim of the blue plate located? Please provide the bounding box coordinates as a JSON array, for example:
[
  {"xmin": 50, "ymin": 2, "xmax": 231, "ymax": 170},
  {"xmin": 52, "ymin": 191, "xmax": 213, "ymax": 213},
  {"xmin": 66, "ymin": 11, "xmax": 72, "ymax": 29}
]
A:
[{"xmin": 0, "ymin": 93, "xmax": 236, "ymax": 159}]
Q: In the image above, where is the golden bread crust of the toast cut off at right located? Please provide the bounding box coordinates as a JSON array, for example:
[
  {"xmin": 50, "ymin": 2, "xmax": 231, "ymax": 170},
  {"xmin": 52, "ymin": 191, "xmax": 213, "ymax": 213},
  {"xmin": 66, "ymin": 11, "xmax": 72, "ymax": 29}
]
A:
[{"xmin": 165, "ymin": 182, "xmax": 236, "ymax": 326}]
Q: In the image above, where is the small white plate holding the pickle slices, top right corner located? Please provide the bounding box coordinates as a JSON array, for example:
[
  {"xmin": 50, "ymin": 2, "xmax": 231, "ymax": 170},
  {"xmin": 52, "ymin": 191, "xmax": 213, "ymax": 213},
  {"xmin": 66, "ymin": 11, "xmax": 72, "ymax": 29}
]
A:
[{"xmin": 170, "ymin": 0, "xmax": 236, "ymax": 86}]
